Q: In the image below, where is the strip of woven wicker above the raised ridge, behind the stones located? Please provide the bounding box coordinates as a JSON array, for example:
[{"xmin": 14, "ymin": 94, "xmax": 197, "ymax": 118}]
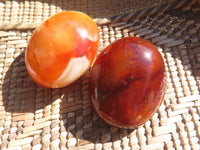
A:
[{"xmin": 0, "ymin": 0, "xmax": 175, "ymax": 23}]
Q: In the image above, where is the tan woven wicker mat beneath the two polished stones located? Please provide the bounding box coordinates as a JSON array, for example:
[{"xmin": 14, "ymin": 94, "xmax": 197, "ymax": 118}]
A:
[{"xmin": 0, "ymin": 0, "xmax": 200, "ymax": 150}]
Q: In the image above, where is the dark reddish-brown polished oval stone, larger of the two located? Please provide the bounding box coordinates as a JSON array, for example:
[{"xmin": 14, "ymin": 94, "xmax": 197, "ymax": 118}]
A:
[{"xmin": 89, "ymin": 37, "xmax": 167, "ymax": 128}]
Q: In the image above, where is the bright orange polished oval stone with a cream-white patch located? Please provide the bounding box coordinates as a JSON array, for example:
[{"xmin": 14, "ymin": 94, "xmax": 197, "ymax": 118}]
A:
[{"xmin": 25, "ymin": 11, "xmax": 99, "ymax": 88}]
